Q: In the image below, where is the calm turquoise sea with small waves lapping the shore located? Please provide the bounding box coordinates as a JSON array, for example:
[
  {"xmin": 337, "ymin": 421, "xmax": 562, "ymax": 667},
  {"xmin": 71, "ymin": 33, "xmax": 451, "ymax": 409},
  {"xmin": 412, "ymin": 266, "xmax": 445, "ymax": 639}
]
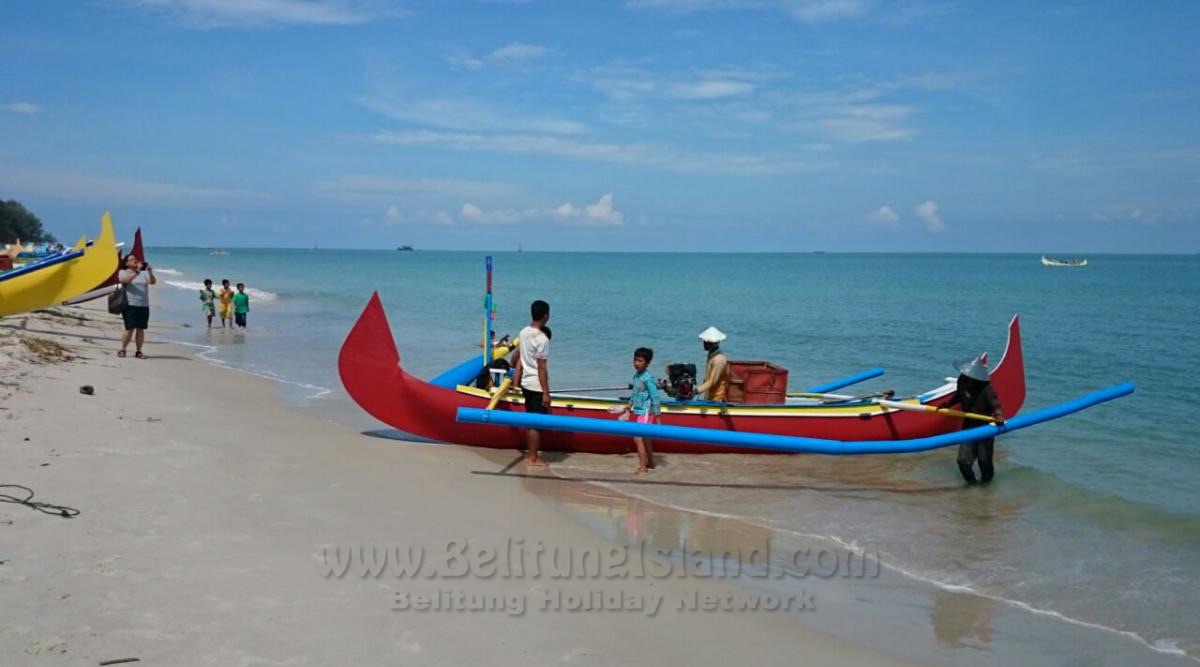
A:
[{"xmin": 140, "ymin": 248, "xmax": 1200, "ymax": 663}]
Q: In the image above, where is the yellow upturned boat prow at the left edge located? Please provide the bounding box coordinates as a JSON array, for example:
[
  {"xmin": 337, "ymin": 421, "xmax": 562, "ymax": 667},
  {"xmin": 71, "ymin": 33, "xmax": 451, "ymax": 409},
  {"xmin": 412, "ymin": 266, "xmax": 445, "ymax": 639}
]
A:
[{"xmin": 0, "ymin": 212, "xmax": 118, "ymax": 317}]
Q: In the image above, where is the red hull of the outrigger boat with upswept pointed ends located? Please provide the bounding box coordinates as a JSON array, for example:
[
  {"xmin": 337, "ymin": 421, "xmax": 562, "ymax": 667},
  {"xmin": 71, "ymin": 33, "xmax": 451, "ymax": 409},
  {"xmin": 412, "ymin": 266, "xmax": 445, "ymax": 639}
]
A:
[{"xmin": 337, "ymin": 294, "xmax": 1025, "ymax": 453}]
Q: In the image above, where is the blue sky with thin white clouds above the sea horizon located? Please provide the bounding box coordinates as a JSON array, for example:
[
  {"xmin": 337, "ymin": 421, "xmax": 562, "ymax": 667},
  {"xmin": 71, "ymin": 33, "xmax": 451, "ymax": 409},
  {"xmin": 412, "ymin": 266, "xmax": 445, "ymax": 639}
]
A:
[{"xmin": 0, "ymin": 0, "xmax": 1200, "ymax": 254}]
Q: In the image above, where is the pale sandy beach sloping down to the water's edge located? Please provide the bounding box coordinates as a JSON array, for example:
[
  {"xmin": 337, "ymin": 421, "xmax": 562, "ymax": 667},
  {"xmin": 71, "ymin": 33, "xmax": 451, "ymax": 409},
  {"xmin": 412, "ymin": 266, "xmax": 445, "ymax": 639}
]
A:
[{"xmin": 0, "ymin": 310, "xmax": 926, "ymax": 666}]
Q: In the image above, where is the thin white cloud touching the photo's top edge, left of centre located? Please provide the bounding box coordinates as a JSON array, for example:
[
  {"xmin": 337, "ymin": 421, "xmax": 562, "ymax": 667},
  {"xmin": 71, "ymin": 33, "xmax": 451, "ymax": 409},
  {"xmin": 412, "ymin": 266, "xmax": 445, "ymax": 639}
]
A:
[{"xmin": 113, "ymin": 0, "xmax": 407, "ymax": 29}]
